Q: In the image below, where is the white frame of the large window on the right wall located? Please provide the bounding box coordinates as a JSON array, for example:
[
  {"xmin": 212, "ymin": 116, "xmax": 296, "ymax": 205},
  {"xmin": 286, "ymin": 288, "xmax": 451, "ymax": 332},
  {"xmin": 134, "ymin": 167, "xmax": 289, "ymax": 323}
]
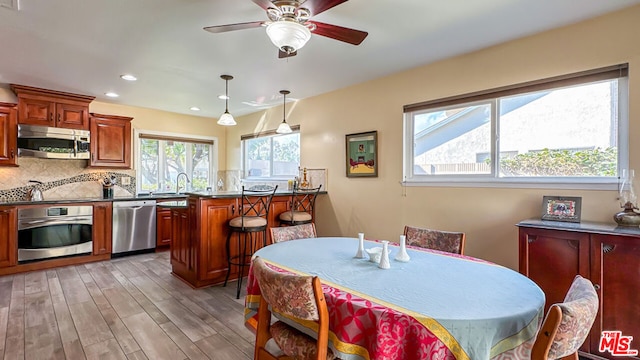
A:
[{"xmin": 402, "ymin": 64, "xmax": 629, "ymax": 190}]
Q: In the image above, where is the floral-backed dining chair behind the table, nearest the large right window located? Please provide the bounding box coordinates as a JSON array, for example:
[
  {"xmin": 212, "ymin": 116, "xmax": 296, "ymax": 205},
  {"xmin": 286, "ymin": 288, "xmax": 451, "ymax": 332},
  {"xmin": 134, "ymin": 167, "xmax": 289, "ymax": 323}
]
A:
[{"xmin": 404, "ymin": 225, "xmax": 466, "ymax": 255}]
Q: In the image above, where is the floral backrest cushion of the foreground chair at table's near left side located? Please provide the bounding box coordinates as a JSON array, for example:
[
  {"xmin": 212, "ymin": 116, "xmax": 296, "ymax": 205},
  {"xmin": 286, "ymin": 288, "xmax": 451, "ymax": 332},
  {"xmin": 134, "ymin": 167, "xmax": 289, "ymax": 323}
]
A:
[{"xmin": 253, "ymin": 257, "xmax": 319, "ymax": 321}]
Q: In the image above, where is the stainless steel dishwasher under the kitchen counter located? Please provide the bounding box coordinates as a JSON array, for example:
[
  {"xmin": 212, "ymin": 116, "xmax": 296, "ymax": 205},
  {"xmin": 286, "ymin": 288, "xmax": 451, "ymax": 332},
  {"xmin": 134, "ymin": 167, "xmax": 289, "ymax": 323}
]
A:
[{"xmin": 111, "ymin": 200, "xmax": 156, "ymax": 256}]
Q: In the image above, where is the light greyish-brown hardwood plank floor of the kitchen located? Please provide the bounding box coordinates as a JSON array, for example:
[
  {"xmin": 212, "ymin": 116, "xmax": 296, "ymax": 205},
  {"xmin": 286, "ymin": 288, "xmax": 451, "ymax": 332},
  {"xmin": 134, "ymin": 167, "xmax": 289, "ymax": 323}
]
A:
[{"xmin": 0, "ymin": 252, "xmax": 254, "ymax": 360}]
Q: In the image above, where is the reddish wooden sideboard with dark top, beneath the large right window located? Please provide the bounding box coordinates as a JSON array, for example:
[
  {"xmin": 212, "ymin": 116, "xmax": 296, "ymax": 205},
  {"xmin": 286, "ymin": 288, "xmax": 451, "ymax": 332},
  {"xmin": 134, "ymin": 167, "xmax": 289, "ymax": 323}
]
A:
[{"xmin": 517, "ymin": 220, "xmax": 640, "ymax": 359}]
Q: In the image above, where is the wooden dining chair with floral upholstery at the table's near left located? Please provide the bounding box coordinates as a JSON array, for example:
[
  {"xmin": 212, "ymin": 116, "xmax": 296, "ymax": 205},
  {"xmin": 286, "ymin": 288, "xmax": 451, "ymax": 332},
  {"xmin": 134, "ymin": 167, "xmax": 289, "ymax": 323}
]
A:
[{"xmin": 252, "ymin": 257, "xmax": 335, "ymax": 360}]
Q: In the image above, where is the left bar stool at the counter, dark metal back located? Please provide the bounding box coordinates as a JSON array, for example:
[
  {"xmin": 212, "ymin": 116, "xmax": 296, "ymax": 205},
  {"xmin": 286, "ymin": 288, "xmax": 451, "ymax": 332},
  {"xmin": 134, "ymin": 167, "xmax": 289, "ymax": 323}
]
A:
[{"xmin": 224, "ymin": 186, "xmax": 278, "ymax": 299}]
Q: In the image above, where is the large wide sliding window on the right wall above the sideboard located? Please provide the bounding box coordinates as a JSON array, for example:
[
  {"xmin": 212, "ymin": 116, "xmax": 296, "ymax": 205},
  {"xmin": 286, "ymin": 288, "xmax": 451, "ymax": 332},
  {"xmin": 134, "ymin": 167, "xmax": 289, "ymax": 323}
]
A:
[{"xmin": 404, "ymin": 65, "xmax": 628, "ymax": 188}]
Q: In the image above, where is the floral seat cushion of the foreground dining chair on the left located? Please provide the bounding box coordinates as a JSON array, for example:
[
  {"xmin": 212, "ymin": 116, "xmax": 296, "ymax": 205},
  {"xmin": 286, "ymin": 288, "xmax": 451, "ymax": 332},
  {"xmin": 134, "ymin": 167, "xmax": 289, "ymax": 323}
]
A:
[{"xmin": 269, "ymin": 321, "xmax": 335, "ymax": 360}]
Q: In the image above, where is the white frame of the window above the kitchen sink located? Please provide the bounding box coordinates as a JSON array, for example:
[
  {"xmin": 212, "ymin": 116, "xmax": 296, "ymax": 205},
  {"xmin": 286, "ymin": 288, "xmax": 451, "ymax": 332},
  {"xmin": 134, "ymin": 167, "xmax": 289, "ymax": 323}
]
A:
[{"xmin": 133, "ymin": 129, "xmax": 219, "ymax": 194}]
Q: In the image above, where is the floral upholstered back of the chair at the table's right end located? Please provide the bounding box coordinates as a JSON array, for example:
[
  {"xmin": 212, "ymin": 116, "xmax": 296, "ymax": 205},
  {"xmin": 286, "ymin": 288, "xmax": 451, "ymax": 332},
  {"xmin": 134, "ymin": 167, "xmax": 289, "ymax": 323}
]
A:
[{"xmin": 548, "ymin": 275, "xmax": 599, "ymax": 359}]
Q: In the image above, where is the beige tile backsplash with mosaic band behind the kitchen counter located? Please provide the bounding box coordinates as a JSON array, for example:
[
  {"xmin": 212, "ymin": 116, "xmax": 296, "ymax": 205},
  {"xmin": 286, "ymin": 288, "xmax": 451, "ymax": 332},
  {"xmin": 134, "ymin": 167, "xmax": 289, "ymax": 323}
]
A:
[{"xmin": 0, "ymin": 157, "xmax": 136, "ymax": 202}]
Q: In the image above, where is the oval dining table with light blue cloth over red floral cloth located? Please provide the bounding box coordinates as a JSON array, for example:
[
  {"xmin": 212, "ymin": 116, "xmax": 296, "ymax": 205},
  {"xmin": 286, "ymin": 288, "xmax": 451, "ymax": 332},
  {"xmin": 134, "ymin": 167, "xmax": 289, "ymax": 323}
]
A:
[{"xmin": 245, "ymin": 237, "xmax": 545, "ymax": 360}]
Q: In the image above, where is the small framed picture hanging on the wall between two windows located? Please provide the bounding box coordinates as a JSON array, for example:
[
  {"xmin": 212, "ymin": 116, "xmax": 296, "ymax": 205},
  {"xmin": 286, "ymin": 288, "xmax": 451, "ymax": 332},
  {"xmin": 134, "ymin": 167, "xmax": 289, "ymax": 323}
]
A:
[{"xmin": 345, "ymin": 131, "xmax": 378, "ymax": 177}]
